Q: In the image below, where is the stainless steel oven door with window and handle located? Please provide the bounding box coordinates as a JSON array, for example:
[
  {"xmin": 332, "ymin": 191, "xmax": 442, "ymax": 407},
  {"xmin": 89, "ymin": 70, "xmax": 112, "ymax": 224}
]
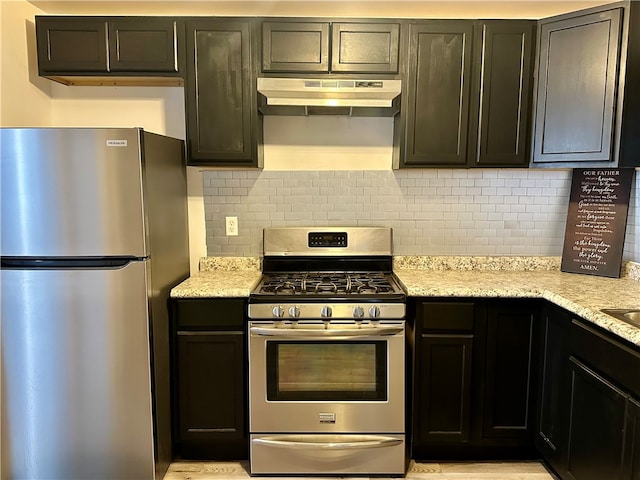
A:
[{"xmin": 249, "ymin": 320, "xmax": 405, "ymax": 434}]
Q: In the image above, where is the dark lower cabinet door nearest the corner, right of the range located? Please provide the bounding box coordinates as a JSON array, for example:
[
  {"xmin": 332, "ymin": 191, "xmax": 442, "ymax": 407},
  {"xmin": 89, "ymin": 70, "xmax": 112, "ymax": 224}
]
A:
[{"xmin": 482, "ymin": 302, "xmax": 537, "ymax": 443}]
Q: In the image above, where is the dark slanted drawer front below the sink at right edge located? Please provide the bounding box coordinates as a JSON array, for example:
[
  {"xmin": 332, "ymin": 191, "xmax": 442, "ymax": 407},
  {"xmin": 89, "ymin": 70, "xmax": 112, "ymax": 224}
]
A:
[{"xmin": 570, "ymin": 320, "xmax": 640, "ymax": 397}]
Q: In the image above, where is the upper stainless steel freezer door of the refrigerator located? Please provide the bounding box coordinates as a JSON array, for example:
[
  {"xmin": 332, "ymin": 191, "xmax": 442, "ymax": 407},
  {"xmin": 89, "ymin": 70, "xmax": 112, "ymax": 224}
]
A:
[{"xmin": 0, "ymin": 128, "xmax": 147, "ymax": 257}]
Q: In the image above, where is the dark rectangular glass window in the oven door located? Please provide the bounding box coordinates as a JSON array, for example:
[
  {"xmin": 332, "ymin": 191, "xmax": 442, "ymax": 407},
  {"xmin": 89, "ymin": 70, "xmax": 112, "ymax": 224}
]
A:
[{"xmin": 267, "ymin": 340, "xmax": 387, "ymax": 401}]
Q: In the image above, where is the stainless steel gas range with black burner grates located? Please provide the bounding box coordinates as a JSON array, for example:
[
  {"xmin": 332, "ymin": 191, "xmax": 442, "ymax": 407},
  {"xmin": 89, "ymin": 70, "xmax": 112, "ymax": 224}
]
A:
[{"xmin": 249, "ymin": 227, "xmax": 407, "ymax": 476}]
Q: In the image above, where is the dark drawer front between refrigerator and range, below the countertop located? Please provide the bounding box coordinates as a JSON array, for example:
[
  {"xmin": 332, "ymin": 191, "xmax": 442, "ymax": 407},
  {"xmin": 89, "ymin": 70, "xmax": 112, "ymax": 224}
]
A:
[{"xmin": 176, "ymin": 298, "xmax": 246, "ymax": 330}]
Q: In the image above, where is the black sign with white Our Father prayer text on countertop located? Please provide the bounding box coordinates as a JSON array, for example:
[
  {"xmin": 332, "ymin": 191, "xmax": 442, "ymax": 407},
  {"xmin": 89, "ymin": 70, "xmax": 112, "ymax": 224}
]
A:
[{"xmin": 561, "ymin": 168, "xmax": 635, "ymax": 278}]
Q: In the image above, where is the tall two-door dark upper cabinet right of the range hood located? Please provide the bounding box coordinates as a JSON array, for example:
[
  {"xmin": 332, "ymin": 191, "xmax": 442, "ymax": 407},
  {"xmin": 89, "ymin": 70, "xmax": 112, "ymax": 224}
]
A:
[{"xmin": 402, "ymin": 20, "xmax": 535, "ymax": 167}]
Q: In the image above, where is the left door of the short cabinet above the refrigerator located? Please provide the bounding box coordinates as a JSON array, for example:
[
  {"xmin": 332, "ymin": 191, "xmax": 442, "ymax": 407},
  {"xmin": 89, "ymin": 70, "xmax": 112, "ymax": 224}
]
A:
[{"xmin": 36, "ymin": 16, "xmax": 109, "ymax": 75}]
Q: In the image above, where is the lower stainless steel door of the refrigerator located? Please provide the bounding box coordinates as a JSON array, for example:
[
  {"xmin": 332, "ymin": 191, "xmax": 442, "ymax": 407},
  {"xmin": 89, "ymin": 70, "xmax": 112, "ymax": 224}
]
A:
[{"xmin": 0, "ymin": 262, "xmax": 154, "ymax": 480}]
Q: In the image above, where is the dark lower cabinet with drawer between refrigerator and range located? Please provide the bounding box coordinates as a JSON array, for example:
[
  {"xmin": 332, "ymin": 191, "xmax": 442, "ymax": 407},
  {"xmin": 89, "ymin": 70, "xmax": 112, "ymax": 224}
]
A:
[{"xmin": 172, "ymin": 299, "xmax": 248, "ymax": 460}]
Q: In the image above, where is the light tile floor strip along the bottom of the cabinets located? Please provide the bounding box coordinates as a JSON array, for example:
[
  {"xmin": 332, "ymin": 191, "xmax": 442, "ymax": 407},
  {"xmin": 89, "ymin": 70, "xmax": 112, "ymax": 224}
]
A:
[{"xmin": 164, "ymin": 461, "xmax": 556, "ymax": 480}]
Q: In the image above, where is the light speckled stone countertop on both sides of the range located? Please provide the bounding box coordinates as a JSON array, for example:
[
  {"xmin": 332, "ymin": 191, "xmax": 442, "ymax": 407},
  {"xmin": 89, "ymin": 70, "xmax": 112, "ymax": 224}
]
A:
[{"xmin": 171, "ymin": 257, "xmax": 640, "ymax": 346}]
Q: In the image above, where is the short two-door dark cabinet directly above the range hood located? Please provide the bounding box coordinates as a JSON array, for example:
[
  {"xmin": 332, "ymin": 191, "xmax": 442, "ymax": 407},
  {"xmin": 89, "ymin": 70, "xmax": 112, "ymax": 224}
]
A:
[{"xmin": 262, "ymin": 21, "xmax": 400, "ymax": 74}]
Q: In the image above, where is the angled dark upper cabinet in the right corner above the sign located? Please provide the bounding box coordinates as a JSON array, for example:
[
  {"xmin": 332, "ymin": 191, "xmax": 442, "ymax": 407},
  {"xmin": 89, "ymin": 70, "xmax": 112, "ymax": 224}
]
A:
[{"xmin": 531, "ymin": 1, "xmax": 640, "ymax": 168}]
